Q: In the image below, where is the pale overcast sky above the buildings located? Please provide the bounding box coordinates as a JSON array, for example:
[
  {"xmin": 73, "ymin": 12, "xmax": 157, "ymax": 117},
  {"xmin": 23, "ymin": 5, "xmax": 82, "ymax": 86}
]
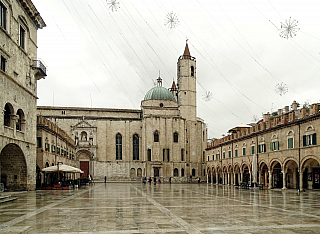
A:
[{"xmin": 33, "ymin": 0, "xmax": 320, "ymax": 138}]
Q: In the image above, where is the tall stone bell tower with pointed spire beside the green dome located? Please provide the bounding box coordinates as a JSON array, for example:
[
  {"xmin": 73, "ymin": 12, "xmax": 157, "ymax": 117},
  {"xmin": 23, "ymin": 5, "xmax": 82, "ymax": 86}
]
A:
[{"xmin": 177, "ymin": 42, "xmax": 197, "ymax": 121}]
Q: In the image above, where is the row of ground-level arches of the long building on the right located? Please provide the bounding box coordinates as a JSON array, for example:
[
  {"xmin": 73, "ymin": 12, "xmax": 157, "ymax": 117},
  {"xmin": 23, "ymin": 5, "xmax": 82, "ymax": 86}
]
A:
[{"xmin": 207, "ymin": 157, "xmax": 320, "ymax": 190}]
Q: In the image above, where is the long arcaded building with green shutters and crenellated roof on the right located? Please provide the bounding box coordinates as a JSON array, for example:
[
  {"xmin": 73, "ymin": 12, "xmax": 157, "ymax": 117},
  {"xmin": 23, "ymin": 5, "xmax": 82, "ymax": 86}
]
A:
[{"xmin": 206, "ymin": 101, "xmax": 320, "ymax": 190}]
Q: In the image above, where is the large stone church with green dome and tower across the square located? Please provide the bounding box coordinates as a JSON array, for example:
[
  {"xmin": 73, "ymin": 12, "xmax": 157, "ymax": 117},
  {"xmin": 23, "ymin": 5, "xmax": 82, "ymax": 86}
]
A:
[{"xmin": 38, "ymin": 44, "xmax": 207, "ymax": 182}]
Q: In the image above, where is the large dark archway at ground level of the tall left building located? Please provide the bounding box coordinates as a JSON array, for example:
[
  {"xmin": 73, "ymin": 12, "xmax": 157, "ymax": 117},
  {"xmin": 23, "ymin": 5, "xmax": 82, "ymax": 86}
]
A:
[{"xmin": 0, "ymin": 143, "xmax": 28, "ymax": 190}]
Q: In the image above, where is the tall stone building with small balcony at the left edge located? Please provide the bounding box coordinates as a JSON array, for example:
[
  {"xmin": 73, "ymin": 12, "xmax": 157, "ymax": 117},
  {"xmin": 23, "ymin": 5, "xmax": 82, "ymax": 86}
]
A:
[{"xmin": 0, "ymin": 0, "xmax": 46, "ymax": 190}]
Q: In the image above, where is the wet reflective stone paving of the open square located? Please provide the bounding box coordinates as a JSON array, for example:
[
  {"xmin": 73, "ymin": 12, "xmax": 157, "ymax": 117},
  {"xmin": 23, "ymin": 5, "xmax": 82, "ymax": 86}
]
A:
[{"xmin": 0, "ymin": 183, "xmax": 320, "ymax": 233}]
